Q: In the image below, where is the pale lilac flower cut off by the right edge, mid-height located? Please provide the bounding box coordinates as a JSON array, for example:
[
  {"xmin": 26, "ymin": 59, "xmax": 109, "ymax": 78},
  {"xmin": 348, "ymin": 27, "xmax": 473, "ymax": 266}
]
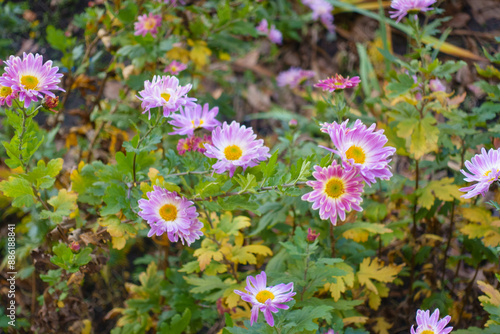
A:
[{"xmin": 460, "ymin": 147, "xmax": 500, "ymax": 198}]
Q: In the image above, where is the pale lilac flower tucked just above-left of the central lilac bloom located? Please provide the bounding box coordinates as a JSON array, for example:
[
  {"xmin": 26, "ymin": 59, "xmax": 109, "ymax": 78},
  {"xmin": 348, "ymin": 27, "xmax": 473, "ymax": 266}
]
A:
[{"xmin": 169, "ymin": 103, "xmax": 220, "ymax": 136}]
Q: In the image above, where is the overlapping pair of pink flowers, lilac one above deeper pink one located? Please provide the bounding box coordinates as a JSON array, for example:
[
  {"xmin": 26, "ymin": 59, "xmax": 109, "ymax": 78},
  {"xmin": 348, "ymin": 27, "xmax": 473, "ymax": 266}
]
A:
[{"xmin": 302, "ymin": 120, "xmax": 396, "ymax": 225}]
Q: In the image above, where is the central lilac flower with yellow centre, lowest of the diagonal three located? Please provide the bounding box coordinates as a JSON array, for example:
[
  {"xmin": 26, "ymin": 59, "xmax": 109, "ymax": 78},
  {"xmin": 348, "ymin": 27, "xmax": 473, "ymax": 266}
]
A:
[{"xmin": 205, "ymin": 121, "xmax": 271, "ymax": 177}]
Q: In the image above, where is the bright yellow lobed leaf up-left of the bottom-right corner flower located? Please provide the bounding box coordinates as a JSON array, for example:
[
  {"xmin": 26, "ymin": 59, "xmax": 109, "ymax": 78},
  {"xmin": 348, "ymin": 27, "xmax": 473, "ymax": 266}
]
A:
[{"xmin": 357, "ymin": 257, "xmax": 404, "ymax": 294}]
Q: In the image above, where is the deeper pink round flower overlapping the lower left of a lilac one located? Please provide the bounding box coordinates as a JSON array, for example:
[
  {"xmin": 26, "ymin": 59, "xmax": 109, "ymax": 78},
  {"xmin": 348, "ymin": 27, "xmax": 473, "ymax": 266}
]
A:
[{"xmin": 302, "ymin": 161, "xmax": 363, "ymax": 225}]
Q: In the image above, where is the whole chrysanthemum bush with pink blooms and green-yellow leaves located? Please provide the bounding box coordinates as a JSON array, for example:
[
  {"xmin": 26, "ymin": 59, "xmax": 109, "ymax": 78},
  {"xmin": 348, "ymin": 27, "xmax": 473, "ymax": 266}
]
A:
[{"xmin": 0, "ymin": 0, "xmax": 500, "ymax": 334}]
